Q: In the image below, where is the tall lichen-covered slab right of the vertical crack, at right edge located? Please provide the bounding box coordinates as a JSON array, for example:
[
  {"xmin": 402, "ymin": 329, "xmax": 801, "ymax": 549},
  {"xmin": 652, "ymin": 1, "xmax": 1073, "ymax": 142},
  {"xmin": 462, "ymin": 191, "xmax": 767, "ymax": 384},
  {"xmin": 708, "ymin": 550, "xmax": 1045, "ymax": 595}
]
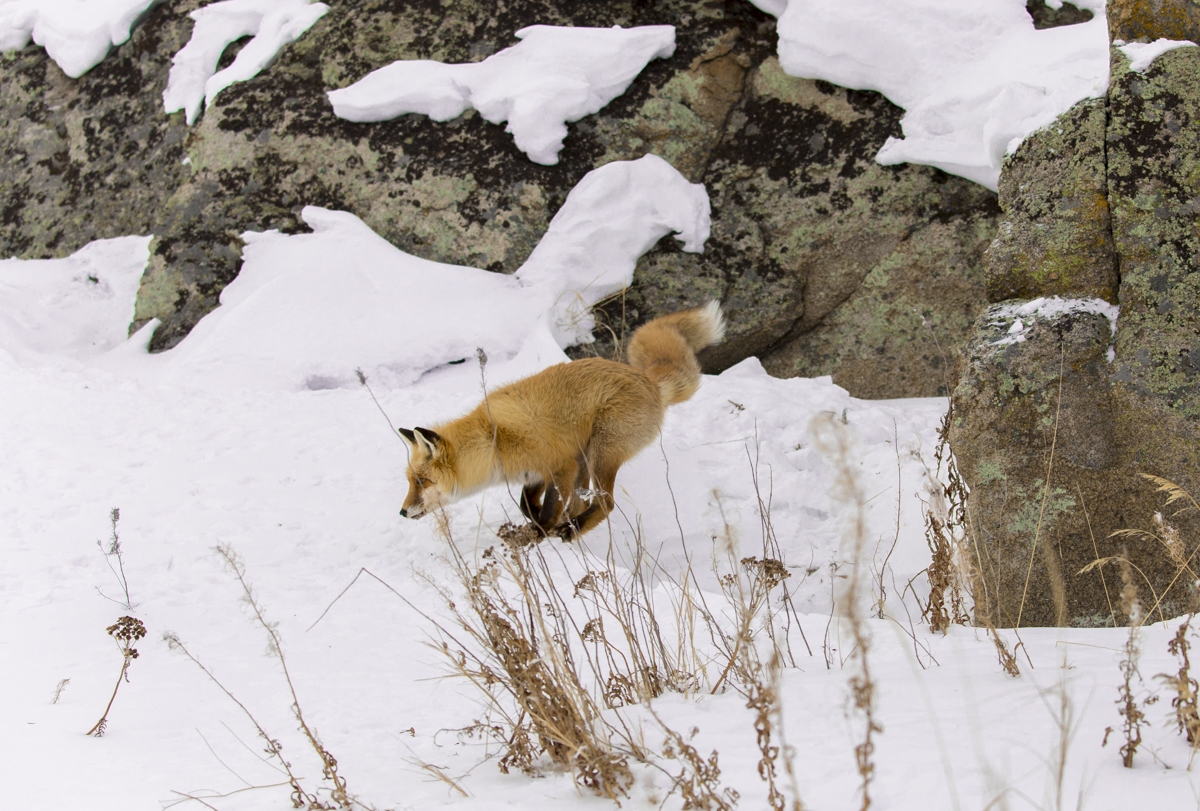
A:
[{"xmin": 1108, "ymin": 48, "xmax": 1200, "ymax": 422}]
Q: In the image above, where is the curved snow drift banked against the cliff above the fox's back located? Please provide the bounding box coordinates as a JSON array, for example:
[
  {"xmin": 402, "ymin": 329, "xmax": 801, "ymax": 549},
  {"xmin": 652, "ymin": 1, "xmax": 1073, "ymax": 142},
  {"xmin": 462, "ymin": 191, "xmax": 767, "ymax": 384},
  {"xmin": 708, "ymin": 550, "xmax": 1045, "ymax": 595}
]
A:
[{"xmin": 174, "ymin": 155, "xmax": 709, "ymax": 389}]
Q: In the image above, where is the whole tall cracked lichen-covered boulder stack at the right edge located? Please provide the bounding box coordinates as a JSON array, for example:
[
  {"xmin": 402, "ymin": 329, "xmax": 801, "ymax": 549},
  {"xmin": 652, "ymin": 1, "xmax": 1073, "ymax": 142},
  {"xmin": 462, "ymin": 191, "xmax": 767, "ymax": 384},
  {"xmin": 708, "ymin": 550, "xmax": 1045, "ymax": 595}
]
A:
[{"xmin": 950, "ymin": 42, "xmax": 1200, "ymax": 626}]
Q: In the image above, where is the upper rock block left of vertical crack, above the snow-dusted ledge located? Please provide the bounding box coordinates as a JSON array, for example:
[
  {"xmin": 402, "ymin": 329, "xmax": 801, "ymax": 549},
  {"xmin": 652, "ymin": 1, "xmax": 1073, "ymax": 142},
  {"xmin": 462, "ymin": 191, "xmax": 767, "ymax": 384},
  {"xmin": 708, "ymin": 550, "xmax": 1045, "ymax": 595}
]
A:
[{"xmin": 985, "ymin": 100, "xmax": 1117, "ymax": 304}]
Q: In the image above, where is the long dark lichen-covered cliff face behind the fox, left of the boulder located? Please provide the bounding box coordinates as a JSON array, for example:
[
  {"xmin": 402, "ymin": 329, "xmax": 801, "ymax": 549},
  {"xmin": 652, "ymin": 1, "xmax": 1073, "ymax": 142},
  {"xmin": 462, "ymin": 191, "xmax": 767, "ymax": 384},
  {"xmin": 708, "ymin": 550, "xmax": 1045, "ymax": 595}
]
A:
[{"xmin": 0, "ymin": 0, "xmax": 998, "ymax": 397}]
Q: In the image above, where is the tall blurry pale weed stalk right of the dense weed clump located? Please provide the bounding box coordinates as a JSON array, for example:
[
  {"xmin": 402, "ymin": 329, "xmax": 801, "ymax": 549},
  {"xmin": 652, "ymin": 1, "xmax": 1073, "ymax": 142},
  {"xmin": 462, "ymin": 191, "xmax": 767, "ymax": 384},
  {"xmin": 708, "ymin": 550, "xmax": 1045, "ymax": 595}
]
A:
[{"xmin": 809, "ymin": 413, "xmax": 883, "ymax": 811}]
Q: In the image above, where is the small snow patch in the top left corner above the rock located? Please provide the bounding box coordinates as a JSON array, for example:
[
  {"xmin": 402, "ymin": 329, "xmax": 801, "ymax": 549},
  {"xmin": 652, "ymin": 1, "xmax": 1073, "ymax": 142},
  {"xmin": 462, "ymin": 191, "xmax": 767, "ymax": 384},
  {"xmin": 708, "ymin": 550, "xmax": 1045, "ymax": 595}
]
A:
[{"xmin": 0, "ymin": 0, "xmax": 158, "ymax": 79}]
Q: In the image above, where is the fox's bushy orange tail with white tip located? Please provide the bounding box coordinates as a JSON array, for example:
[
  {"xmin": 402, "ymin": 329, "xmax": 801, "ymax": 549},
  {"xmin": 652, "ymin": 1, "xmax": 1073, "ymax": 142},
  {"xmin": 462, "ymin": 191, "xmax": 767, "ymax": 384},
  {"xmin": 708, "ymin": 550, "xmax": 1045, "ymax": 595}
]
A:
[{"xmin": 628, "ymin": 301, "xmax": 725, "ymax": 406}]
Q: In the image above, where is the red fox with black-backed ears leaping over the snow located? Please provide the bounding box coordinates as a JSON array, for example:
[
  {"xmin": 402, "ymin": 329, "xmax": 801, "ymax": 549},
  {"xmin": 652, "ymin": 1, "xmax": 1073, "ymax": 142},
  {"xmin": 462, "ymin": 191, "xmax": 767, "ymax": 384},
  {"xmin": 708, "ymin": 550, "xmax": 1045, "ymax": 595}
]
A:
[{"xmin": 400, "ymin": 301, "xmax": 725, "ymax": 539}]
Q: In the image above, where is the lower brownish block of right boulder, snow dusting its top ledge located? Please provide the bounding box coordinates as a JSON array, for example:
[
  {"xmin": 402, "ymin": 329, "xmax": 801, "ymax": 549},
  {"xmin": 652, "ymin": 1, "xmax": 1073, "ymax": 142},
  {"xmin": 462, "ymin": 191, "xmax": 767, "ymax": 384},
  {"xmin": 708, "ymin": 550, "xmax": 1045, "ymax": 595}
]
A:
[{"xmin": 950, "ymin": 302, "xmax": 1200, "ymax": 627}]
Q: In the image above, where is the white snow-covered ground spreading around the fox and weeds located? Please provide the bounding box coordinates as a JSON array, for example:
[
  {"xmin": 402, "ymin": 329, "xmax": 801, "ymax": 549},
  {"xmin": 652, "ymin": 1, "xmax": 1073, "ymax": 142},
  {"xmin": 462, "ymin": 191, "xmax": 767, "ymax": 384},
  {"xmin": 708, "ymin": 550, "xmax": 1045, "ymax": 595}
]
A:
[{"xmin": 0, "ymin": 0, "xmax": 1200, "ymax": 811}]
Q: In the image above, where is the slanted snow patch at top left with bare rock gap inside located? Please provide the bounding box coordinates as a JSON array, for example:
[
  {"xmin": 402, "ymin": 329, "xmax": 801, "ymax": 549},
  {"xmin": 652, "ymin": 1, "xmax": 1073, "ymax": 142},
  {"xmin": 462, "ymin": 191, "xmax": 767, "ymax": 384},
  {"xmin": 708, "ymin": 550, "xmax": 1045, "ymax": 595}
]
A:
[{"xmin": 162, "ymin": 0, "xmax": 329, "ymax": 125}]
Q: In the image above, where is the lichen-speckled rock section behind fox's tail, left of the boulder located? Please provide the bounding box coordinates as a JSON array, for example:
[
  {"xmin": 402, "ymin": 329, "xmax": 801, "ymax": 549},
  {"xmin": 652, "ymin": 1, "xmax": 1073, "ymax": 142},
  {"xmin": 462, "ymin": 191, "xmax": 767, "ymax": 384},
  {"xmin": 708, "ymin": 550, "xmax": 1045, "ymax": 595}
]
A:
[{"xmin": 585, "ymin": 56, "xmax": 997, "ymax": 397}]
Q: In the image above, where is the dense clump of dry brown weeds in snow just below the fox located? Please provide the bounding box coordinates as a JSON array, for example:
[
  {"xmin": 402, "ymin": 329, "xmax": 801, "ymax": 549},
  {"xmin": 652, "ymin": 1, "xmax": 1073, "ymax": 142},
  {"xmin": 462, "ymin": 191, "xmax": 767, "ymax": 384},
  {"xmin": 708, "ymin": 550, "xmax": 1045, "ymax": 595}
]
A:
[{"xmin": 417, "ymin": 494, "xmax": 800, "ymax": 811}]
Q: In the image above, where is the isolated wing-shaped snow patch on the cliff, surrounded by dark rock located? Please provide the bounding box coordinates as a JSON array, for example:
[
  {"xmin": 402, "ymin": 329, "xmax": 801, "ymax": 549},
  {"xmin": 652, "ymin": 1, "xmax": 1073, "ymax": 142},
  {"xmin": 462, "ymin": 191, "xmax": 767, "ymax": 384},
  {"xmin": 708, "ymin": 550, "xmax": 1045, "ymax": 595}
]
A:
[{"xmin": 329, "ymin": 25, "xmax": 674, "ymax": 166}]
